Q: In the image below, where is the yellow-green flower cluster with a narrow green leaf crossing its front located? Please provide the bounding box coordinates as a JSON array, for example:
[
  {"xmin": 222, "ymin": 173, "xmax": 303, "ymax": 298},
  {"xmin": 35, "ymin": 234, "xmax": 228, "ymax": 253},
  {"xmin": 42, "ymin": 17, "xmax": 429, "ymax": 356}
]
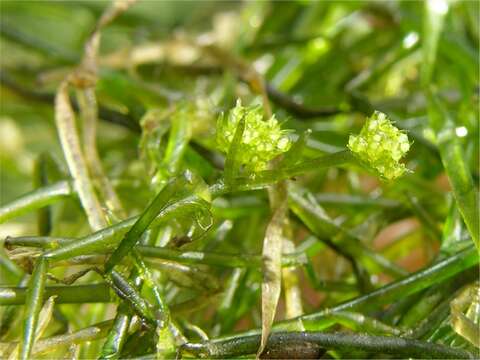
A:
[{"xmin": 217, "ymin": 100, "xmax": 291, "ymax": 171}]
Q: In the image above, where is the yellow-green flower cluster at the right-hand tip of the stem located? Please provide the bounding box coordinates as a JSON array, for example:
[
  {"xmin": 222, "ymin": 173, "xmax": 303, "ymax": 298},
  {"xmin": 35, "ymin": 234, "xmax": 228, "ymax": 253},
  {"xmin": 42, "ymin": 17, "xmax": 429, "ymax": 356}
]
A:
[{"xmin": 348, "ymin": 111, "xmax": 410, "ymax": 180}]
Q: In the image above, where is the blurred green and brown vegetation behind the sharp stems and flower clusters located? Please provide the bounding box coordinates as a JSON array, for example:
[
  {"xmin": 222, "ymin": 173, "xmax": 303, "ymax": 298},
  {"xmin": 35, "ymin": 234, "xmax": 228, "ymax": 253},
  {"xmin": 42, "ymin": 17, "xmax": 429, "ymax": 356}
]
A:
[{"xmin": 0, "ymin": 1, "xmax": 480, "ymax": 358}]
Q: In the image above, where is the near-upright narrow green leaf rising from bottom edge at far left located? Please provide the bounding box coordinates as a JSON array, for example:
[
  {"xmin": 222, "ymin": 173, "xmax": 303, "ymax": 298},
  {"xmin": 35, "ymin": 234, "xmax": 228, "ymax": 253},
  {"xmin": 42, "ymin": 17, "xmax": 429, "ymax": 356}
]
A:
[{"xmin": 19, "ymin": 257, "xmax": 48, "ymax": 360}]
